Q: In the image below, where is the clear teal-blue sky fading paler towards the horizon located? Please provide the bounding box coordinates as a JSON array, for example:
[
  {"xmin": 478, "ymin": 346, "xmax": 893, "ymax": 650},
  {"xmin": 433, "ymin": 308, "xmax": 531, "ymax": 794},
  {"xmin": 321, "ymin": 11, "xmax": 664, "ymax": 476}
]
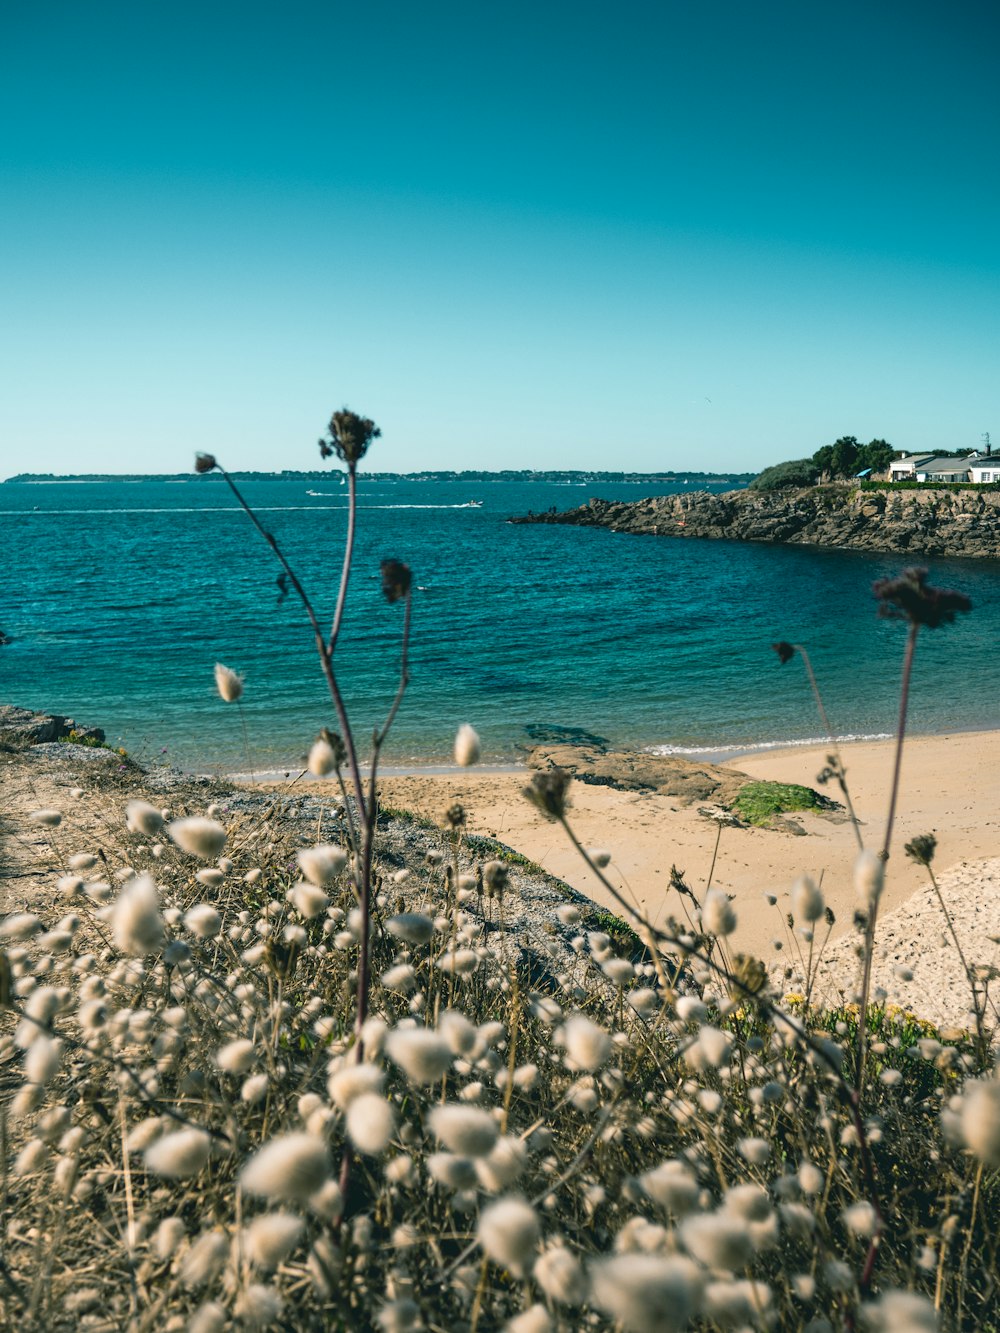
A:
[{"xmin": 0, "ymin": 0, "xmax": 1000, "ymax": 476}]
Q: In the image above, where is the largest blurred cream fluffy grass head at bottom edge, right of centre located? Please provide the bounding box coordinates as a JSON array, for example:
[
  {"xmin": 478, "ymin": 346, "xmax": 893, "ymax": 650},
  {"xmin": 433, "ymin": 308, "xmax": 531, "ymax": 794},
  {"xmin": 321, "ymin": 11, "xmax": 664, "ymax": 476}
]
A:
[{"xmin": 591, "ymin": 1254, "xmax": 701, "ymax": 1333}]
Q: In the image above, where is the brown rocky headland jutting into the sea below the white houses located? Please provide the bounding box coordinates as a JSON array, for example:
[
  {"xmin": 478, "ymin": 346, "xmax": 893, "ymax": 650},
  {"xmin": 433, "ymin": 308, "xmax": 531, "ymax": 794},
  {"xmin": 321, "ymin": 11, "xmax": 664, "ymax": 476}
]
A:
[{"xmin": 511, "ymin": 485, "xmax": 1000, "ymax": 560}]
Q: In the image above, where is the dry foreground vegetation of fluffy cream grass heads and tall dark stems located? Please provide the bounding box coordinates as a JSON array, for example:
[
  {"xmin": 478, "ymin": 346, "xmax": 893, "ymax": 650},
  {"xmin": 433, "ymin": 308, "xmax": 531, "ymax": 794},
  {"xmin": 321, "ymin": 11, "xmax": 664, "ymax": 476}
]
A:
[{"xmin": 0, "ymin": 409, "xmax": 1000, "ymax": 1333}]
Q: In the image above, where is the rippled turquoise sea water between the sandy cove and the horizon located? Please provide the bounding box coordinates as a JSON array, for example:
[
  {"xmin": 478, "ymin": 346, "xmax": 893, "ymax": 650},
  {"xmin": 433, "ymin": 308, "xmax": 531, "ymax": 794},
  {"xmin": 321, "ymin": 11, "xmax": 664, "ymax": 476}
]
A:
[{"xmin": 0, "ymin": 473, "xmax": 1000, "ymax": 769}]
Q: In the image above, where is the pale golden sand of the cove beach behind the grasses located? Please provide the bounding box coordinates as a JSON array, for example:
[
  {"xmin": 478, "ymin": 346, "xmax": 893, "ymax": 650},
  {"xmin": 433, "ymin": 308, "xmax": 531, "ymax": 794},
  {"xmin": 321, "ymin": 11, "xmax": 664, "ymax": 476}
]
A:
[{"xmin": 370, "ymin": 732, "xmax": 1000, "ymax": 1007}]
